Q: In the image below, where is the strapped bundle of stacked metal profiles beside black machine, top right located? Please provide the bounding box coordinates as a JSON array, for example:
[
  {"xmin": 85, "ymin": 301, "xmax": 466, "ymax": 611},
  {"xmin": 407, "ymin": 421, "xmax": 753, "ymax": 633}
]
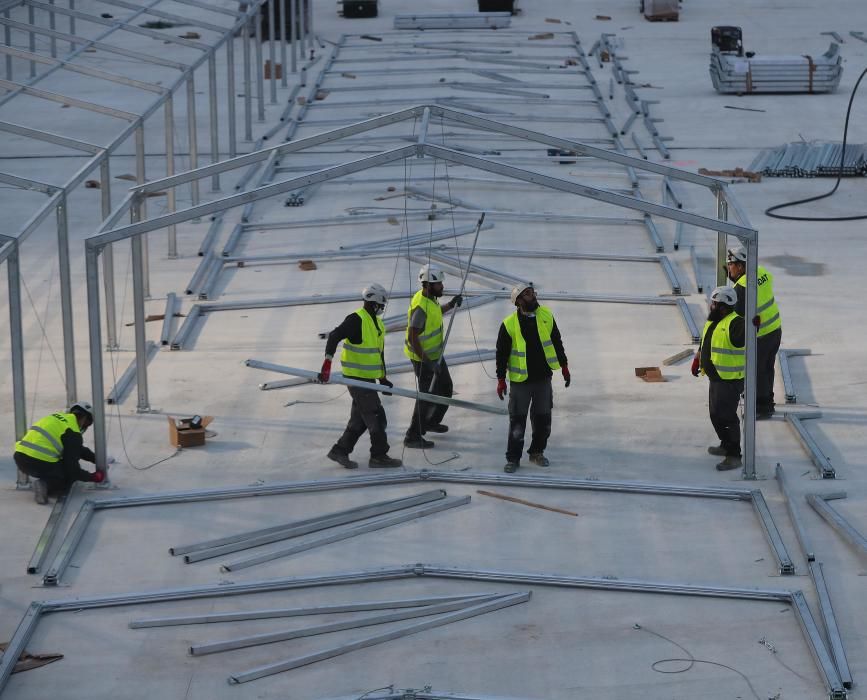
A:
[{"xmin": 710, "ymin": 43, "xmax": 843, "ymax": 95}]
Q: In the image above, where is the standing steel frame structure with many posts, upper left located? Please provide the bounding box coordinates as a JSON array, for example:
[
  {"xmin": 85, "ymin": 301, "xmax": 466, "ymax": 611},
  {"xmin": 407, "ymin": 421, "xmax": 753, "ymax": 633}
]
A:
[{"xmin": 0, "ymin": 0, "xmax": 307, "ymax": 487}]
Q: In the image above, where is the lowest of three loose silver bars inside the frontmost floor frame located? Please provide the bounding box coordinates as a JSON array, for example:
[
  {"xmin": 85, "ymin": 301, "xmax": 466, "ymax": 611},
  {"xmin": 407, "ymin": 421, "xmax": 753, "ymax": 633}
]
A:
[{"xmin": 229, "ymin": 591, "xmax": 531, "ymax": 683}]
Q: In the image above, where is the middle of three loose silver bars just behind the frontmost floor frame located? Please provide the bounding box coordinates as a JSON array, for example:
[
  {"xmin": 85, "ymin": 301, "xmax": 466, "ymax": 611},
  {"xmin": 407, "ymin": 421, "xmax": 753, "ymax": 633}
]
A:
[{"xmin": 183, "ymin": 489, "xmax": 446, "ymax": 564}]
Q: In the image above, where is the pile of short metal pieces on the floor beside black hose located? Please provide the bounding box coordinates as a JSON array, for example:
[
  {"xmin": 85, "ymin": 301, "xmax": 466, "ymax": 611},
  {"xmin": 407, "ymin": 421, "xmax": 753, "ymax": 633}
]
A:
[{"xmin": 749, "ymin": 142, "xmax": 867, "ymax": 177}]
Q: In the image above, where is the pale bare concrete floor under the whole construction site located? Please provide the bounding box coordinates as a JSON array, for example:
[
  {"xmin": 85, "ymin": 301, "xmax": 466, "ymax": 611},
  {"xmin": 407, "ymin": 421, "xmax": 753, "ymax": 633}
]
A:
[{"xmin": 0, "ymin": 0, "xmax": 867, "ymax": 700}]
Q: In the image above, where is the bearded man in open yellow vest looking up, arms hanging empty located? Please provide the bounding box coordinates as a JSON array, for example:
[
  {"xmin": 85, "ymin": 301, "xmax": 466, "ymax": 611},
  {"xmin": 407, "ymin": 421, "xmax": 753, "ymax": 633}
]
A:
[{"xmin": 497, "ymin": 284, "xmax": 572, "ymax": 473}]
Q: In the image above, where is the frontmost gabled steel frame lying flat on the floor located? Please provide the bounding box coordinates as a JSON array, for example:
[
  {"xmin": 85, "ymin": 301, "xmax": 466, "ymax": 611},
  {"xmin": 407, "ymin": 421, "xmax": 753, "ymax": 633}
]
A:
[{"xmin": 0, "ymin": 563, "xmax": 847, "ymax": 700}]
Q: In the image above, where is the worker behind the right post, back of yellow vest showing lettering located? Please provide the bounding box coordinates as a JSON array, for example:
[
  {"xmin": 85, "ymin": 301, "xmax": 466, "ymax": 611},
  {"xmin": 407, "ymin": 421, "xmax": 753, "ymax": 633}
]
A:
[{"xmin": 726, "ymin": 246, "xmax": 783, "ymax": 420}]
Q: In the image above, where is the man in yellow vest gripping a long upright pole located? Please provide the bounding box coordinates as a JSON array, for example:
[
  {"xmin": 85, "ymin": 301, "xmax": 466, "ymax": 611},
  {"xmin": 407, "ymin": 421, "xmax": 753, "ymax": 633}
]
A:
[{"xmin": 403, "ymin": 265, "xmax": 463, "ymax": 449}]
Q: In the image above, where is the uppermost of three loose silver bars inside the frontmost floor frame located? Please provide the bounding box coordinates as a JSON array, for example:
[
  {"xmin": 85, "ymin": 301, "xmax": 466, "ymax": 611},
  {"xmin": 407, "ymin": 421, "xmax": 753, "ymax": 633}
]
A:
[{"xmin": 129, "ymin": 594, "xmax": 496, "ymax": 629}]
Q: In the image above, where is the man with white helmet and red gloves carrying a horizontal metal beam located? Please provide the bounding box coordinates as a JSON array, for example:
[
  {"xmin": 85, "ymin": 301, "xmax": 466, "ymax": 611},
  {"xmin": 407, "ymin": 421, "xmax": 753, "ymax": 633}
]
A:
[{"xmin": 319, "ymin": 283, "xmax": 402, "ymax": 469}]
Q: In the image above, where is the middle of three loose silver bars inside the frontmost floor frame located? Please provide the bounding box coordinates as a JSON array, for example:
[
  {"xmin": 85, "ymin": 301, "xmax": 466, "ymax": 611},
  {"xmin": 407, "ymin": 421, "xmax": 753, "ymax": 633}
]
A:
[{"xmin": 190, "ymin": 594, "xmax": 492, "ymax": 656}]
